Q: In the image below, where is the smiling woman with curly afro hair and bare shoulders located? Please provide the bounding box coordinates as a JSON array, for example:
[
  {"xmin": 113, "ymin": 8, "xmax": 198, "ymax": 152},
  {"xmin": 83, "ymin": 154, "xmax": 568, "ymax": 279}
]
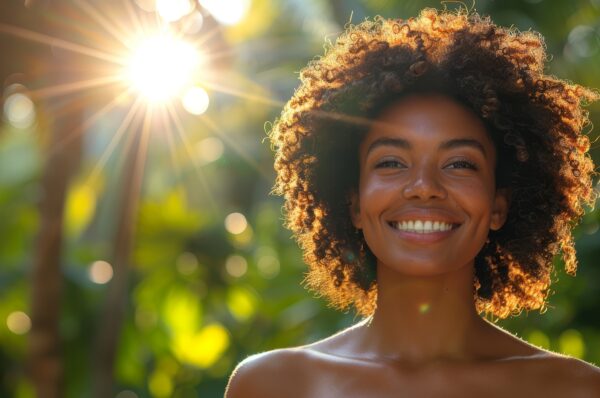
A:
[{"xmin": 226, "ymin": 9, "xmax": 600, "ymax": 398}]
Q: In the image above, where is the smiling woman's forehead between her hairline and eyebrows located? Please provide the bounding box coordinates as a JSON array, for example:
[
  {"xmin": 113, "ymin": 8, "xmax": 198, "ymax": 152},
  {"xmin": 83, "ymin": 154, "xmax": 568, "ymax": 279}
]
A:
[{"xmin": 361, "ymin": 94, "xmax": 494, "ymax": 152}]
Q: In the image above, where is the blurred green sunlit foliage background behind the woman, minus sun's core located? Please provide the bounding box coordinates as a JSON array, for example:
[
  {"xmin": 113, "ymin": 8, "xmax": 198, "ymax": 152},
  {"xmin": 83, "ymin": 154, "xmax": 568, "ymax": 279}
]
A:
[{"xmin": 0, "ymin": 0, "xmax": 600, "ymax": 398}]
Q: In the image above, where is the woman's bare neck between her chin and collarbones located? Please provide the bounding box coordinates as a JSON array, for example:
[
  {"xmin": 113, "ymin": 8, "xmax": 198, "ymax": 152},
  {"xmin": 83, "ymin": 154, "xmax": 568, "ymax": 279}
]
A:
[{"xmin": 363, "ymin": 264, "xmax": 484, "ymax": 363}]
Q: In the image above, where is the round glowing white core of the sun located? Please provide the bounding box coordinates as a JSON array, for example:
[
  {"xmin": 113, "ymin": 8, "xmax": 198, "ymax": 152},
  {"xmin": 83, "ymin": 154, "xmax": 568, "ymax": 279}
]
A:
[{"xmin": 127, "ymin": 35, "xmax": 201, "ymax": 103}]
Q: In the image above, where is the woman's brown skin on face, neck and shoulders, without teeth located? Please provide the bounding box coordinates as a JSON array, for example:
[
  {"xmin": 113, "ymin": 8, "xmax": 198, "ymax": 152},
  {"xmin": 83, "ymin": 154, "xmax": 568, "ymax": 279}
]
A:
[{"xmin": 226, "ymin": 95, "xmax": 600, "ymax": 398}]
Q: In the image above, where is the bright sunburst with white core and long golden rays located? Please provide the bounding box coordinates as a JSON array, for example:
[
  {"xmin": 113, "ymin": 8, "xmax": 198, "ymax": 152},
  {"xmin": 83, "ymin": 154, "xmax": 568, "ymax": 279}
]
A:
[{"xmin": 0, "ymin": 0, "xmax": 282, "ymax": 202}]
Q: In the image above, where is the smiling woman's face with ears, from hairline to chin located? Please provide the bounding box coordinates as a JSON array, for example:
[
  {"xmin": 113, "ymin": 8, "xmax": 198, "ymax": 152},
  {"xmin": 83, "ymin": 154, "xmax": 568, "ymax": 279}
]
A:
[{"xmin": 351, "ymin": 95, "xmax": 507, "ymax": 276}]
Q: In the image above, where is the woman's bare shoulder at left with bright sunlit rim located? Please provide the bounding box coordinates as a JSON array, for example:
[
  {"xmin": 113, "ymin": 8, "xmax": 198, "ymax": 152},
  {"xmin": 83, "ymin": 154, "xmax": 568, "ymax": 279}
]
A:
[{"xmin": 225, "ymin": 348, "xmax": 310, "ymax": 398}]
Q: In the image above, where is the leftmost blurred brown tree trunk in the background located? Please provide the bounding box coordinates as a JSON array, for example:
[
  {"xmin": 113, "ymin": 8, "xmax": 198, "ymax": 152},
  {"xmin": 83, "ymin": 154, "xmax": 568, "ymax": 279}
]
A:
[{"xmin": 28, "ymin": 49, "xmax": 81, "ymax": 398}]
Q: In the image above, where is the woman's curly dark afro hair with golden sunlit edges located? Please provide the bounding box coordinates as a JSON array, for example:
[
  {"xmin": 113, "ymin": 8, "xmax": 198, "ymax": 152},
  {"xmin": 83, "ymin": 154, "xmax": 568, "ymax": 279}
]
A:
[{"xmin": 270, "ymin": 9, "xmax": 599, "ymax": 318}]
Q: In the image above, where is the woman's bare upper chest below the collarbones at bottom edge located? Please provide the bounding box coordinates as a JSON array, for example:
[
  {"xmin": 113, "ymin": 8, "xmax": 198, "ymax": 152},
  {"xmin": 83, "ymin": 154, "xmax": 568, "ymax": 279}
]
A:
[{"xmin": 291, "ymin": 363, "xmax": 576, "ymax": 398}]
